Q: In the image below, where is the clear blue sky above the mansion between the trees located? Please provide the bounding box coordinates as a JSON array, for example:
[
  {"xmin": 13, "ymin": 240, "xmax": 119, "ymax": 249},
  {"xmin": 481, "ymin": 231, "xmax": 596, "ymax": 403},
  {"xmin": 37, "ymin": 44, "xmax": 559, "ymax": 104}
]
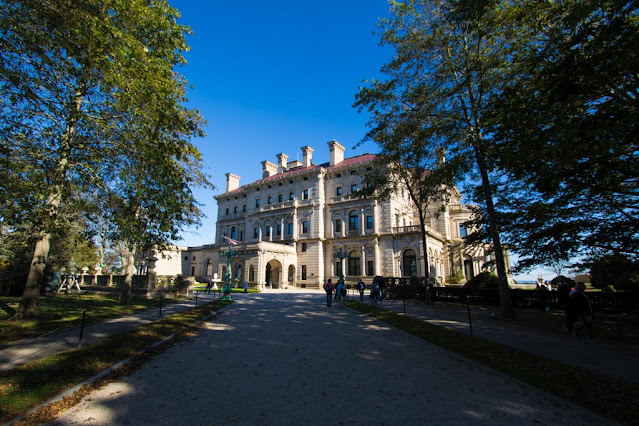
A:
[{"xmin": 169, "ymin": 0, "xmax": 554, "ymax": 279}]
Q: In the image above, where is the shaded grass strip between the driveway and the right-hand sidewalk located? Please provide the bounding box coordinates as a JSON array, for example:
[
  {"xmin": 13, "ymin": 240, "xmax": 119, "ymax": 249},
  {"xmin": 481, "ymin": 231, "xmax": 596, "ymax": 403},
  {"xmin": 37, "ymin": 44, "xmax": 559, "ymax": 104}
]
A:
[{"xmin": 346, "ymin": 301, "xmax": 639, "ymax": 424}]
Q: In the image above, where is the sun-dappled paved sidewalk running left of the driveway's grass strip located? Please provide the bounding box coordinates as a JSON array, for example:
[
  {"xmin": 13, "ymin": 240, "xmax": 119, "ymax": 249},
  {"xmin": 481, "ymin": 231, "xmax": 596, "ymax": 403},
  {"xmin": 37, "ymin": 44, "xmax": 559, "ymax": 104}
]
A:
[{"xmin": 0, "ymin": 294, "xmax": 219, "ymax": 373}]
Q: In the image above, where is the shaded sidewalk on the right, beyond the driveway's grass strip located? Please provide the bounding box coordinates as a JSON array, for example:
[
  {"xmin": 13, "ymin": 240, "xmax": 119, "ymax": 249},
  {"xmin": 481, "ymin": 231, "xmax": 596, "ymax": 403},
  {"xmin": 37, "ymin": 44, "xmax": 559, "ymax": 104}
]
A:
[{"xmin": 364, "ymin": 295, "xmax": 639, "ymax": 383}]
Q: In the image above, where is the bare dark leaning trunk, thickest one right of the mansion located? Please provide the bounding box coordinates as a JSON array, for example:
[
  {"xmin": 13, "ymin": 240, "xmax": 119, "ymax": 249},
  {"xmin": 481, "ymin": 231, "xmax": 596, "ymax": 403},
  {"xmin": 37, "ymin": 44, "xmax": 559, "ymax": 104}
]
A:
[{"xmin": 473, "ymin": 144, "xmax": 515, "ymax": 319}]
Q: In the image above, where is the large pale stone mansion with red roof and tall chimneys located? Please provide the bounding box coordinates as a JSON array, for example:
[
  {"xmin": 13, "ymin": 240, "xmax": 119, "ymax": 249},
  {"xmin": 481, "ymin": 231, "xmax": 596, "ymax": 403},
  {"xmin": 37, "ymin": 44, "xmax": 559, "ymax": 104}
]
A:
[{"xmin": 181, "ymin": 141, "xmax": 504, "ymax": 288}]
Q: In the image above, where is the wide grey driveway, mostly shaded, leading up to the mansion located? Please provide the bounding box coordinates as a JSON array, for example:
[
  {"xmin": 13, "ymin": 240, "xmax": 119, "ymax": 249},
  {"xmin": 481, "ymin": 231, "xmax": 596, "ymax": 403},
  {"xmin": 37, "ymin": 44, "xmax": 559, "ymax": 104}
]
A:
[{"xmin": 51, "ymin": 290, "xmax": 612, "ymax": 425}]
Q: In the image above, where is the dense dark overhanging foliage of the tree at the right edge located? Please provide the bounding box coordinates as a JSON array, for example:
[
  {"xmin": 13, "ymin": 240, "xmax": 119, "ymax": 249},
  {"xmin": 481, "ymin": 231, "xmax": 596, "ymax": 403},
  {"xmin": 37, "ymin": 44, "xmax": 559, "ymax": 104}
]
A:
[{"xmin": 491, "ymin": 0, "xmax": 639, "ymax": 267}]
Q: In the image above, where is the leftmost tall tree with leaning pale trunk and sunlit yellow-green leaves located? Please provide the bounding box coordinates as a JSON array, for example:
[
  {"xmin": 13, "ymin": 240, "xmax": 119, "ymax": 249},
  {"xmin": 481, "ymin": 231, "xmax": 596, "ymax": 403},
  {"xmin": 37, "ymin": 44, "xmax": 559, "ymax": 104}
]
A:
[{"xmin": 0, "ymin": 0, "xmax": 208, "ymax": 318}]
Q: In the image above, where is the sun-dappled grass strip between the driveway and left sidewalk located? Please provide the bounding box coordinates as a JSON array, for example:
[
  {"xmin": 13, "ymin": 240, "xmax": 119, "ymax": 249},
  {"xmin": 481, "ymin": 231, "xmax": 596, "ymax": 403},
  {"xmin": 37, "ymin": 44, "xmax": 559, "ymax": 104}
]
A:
[{"xmin": 0, "ymin": 300, "xmax": 231, "ymax": 424}]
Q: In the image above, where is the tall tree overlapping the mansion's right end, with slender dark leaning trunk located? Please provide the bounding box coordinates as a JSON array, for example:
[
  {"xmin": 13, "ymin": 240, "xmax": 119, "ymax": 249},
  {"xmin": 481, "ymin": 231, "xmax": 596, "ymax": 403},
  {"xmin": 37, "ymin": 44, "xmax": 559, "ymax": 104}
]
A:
[{"xmin": 356, "ymin": 0, "xmax": 516, "ymax": 318}]
